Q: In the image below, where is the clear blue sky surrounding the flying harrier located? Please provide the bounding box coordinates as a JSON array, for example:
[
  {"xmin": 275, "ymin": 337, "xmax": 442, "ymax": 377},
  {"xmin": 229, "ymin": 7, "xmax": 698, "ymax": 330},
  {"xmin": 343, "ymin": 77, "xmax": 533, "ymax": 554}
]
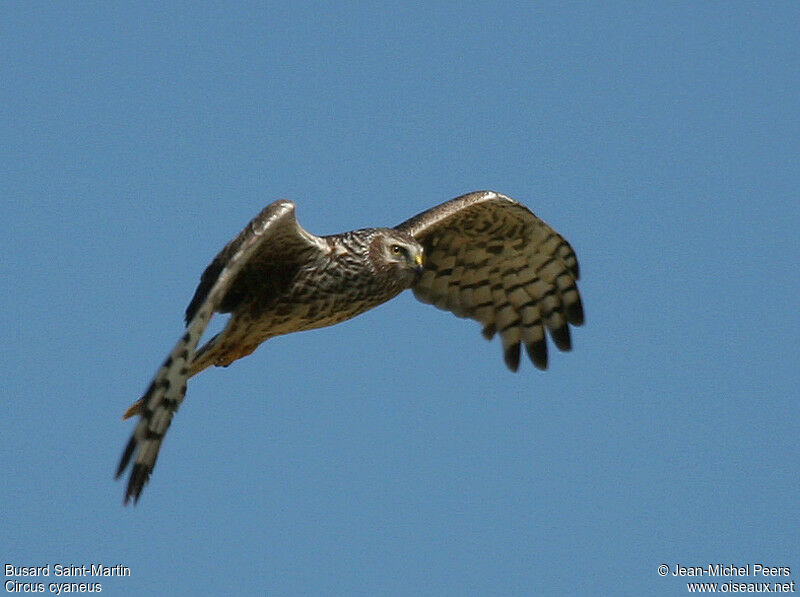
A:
[{"xmin": 0, "ymin": 2, "xmax": 800, "ymax": 595}]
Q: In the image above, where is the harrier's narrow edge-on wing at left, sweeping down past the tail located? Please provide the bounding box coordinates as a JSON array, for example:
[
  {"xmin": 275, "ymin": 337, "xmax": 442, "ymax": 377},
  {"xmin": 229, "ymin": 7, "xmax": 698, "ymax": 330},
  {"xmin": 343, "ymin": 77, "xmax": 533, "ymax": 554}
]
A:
[{"xmin": 116, "ymin": 200, "xmax": 327, "ymax": 503}]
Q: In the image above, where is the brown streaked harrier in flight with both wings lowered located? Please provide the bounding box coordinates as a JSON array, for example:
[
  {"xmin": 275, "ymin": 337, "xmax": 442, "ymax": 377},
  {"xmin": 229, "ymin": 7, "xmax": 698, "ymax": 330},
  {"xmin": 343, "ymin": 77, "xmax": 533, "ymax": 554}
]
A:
[{"xmin": 116, "ymin": 191, "xmax": 583, "ymax": 504}]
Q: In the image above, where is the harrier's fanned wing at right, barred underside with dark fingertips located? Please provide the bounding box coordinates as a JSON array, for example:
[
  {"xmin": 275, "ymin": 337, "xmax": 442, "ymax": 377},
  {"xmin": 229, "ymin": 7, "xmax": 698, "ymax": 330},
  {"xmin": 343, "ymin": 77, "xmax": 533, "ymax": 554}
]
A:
[{"xmin": 397, "ymin": 191, "xmax": 583, "ymax": 371}]
